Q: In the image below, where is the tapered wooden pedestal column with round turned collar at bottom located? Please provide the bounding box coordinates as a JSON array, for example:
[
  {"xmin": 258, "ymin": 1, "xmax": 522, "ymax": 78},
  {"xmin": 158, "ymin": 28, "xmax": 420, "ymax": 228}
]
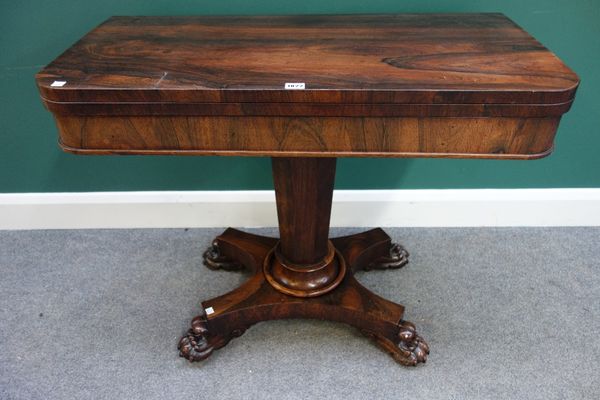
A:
[{"xmin": 264, "ymin": 158, "xmax": 346, "ymax": 297}]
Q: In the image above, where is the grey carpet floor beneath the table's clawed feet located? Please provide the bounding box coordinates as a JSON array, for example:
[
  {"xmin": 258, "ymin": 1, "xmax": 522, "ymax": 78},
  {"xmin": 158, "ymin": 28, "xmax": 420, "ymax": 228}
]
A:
[{"xmin": 0, "ymin": 228, "xmax": 600, "ymax": 400}]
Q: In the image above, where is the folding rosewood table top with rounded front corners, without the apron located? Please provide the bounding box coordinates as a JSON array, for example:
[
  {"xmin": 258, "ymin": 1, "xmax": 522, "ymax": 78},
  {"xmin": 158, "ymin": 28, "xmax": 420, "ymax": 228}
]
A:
[{"xmin": 37, "ymin": 14, "xmax": 579, "ymax": 109}]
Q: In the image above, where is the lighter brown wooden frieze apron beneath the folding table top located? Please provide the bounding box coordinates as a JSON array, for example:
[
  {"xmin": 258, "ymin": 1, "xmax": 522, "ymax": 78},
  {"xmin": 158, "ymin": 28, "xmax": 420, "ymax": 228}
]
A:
[{"xmin": 57, "ymin": 116, "xmax": 559, "ymax": 159}]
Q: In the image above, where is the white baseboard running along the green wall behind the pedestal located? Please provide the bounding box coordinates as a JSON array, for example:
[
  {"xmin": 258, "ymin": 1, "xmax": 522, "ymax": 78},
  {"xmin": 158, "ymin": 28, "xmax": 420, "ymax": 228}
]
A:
[{"xmin": 0, "ymin": 188, "xmax": 600, "ymax": 229}]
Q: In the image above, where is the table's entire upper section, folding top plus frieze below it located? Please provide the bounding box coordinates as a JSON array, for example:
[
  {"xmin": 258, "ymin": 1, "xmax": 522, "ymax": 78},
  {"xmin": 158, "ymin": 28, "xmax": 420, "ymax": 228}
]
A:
[{"xmin": 37, "ymin": 14, "xmax": 579, "ymax": 158}]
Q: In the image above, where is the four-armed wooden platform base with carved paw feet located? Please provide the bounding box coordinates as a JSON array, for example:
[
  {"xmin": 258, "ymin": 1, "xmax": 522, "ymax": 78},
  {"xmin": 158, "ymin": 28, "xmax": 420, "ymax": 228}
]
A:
[{"xmin": 179, "ymin": 229, "xmax": 429, "ymax": 366}]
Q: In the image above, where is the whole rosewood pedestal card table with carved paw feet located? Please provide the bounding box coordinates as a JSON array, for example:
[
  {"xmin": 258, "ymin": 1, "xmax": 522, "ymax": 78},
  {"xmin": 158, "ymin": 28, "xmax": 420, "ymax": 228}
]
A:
[{"xmin": 36, "ymin": 14, "xmax": 579, "ymax": 365}]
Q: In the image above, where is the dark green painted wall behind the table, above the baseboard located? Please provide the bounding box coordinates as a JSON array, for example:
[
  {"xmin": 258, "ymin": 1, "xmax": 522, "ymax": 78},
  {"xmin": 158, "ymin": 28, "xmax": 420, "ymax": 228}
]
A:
[{"xmin": 0, "ymin": 0, "xmax": 600, "ymax": 193}]
